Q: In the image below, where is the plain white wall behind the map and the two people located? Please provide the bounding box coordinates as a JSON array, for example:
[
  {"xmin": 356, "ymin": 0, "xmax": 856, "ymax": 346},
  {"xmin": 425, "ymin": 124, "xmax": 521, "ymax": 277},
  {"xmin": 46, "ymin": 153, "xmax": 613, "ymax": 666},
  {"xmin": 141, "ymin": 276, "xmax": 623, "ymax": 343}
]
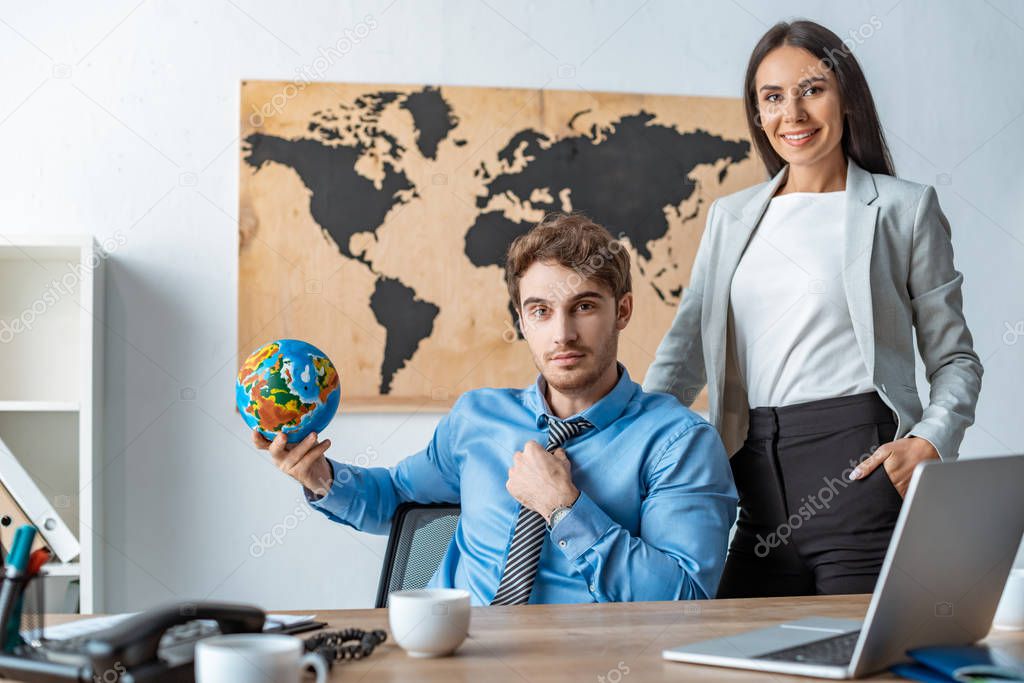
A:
[{"xmin": 0, "ymin": 0, "xmax": 1024, "ymax": 610}]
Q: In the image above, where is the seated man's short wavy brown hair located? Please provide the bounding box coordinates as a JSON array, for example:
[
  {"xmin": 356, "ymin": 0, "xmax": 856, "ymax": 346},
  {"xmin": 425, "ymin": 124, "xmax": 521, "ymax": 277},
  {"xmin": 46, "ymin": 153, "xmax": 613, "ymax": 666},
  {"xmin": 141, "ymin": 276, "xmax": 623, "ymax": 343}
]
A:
[{"xmin": 505, "ymin": 213, "xmax": 633, "ymax": 310}]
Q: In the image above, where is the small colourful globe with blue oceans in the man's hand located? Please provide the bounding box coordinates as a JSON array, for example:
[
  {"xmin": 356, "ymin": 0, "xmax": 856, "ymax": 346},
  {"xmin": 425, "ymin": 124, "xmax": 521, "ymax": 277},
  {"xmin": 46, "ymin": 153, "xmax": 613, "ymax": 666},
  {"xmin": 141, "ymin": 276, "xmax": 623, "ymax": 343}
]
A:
[{"xmin": 234, "ymin": 339, "xmax": 341, "ymax": 443}]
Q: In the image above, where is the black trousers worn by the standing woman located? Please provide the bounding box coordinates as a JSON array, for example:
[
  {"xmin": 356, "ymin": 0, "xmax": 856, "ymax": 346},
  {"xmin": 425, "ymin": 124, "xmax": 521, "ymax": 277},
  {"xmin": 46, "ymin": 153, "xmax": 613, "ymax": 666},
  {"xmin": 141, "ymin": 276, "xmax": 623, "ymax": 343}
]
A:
[{"xmin": 718, "ymin": 392, "xmax": 903, "ymax": 598}]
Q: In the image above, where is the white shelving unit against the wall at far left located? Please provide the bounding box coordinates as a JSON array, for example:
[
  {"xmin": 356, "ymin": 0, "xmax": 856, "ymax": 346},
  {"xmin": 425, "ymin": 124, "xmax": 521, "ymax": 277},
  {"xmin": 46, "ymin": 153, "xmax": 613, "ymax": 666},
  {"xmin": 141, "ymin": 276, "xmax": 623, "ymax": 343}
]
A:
[{"xmin": 0, "ymin": 234, "xmax": 105, "ymax": 613}]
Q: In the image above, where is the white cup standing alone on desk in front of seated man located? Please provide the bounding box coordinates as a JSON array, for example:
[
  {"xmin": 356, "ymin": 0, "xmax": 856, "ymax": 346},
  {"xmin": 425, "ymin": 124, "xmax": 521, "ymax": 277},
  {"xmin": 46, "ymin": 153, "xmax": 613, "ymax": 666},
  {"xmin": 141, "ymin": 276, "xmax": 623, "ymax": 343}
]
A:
[{"xmin": 387, "ymin": 588, "xmax": 469, "ymax": 657}]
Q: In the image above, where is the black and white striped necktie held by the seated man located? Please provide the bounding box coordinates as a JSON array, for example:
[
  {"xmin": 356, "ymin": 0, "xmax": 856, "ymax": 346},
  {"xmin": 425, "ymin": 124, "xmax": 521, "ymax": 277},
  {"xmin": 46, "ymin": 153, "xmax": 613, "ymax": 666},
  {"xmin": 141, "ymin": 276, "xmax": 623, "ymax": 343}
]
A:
[{"xmin": 490, "ymin": 416, "xmax": 594, "ymax": 605}]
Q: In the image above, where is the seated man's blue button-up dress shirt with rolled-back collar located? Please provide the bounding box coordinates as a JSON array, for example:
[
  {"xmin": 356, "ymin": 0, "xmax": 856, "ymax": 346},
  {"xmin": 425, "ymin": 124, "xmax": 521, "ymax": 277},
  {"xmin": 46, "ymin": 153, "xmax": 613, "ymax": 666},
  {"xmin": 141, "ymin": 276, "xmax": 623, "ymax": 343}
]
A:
[{"xmin": 306, "ymin": 364, "xmax": 736, "ymax": 605}]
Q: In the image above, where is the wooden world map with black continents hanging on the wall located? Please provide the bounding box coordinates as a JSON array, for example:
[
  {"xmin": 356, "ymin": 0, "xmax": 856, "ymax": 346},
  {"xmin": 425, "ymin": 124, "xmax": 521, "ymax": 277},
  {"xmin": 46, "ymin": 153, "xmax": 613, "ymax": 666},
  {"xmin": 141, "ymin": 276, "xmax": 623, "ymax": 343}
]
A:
[{"xmin": 239, "ymin": 81, "xmax": 764, "ymax": 412}]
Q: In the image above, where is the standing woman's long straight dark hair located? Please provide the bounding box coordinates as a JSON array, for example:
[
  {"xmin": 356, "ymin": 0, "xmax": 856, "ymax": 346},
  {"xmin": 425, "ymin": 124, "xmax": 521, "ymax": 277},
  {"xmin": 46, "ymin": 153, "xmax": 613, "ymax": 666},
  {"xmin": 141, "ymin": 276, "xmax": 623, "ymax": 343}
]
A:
[{"xmin": 743, "ymin": 20, "xmax": 896, "ymax": 176}]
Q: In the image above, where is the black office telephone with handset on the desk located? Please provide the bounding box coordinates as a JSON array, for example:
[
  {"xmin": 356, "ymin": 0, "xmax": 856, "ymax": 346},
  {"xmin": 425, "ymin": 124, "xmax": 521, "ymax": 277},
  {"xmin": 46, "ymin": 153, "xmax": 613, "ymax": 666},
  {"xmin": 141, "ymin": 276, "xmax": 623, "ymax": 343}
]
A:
[{"xmin": 0, "ymin": 602, "xmax": 324, "ymax": 683}]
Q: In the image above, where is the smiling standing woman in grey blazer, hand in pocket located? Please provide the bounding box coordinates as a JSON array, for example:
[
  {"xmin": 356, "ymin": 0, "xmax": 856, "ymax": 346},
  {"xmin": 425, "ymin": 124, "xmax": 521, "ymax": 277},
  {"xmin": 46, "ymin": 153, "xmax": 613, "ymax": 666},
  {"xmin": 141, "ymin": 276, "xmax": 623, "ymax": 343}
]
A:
[{"xmin": 644, "ymin": 17, "xmax": 982, "ymax": 597}]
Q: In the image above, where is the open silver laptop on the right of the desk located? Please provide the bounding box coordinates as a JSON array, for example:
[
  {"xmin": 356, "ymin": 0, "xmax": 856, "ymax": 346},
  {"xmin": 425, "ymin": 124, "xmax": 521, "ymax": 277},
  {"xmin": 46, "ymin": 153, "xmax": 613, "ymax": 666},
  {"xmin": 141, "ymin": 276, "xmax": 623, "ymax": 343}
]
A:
[{"xmin": 662, "ymin": 456, "xmax": 1024, "ymax": 679}]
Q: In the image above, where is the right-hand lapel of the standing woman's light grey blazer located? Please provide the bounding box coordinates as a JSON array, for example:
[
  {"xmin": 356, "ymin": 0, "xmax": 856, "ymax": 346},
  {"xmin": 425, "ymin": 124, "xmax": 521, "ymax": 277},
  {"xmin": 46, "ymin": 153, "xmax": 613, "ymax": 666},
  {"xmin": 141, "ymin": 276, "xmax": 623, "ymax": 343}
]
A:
[{"xmin": 843, "ymin": 160, "xmax": 879, "ymax": 380}]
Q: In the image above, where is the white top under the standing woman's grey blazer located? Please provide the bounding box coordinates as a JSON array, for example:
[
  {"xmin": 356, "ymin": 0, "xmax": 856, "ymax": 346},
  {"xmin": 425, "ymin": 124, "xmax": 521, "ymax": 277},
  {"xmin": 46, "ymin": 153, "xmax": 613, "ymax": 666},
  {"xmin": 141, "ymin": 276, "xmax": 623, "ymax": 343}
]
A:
[{"xmin": 729, "ymin": 191, "xmax": 874, "ymax": 408}]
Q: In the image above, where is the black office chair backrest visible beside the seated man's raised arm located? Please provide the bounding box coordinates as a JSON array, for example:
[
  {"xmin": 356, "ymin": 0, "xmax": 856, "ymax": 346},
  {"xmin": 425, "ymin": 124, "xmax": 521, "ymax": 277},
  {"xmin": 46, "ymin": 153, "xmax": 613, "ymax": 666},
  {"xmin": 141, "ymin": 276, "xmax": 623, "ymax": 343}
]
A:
[{"xmin": 376, "ymin": 503, "xmax": 462, "ymax": 607}]
